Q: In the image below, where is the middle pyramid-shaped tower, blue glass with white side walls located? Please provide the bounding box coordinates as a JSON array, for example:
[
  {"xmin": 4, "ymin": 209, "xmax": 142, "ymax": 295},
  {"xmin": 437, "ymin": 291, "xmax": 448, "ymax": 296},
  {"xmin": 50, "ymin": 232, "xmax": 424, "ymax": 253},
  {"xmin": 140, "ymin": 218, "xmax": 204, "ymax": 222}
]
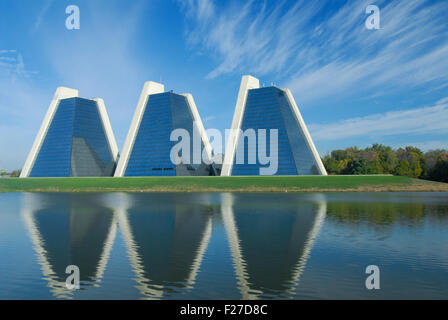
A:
[{"xmin": 115, "ymin": 81, "xmax": 215, "ymax": 177}]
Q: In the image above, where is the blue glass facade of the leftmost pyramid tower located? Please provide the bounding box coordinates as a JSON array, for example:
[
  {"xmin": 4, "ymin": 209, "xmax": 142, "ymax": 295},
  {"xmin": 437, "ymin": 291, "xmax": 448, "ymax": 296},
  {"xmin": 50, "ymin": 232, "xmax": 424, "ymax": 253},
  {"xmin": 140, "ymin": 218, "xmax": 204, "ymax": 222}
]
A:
[{"xmin": 30, "ymin": 98, "xmax": 115, "ymax": 177}]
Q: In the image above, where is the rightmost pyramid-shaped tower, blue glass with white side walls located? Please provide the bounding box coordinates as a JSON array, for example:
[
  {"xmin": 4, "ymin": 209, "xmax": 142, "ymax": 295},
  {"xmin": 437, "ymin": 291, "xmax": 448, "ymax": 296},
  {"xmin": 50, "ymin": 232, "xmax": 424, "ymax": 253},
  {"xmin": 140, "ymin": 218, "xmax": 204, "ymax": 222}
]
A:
[{"xmin": 221, "ymin": 76, "xmax": 327, "ymax": 176}]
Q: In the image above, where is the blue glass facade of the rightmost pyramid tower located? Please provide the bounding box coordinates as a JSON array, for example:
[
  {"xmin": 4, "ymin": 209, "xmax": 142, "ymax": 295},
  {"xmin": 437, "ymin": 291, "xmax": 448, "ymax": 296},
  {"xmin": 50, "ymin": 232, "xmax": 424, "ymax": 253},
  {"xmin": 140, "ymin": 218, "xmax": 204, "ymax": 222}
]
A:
[{"xmin": 231, "ymin": 87, "xmax": 318, "ymax": 176}]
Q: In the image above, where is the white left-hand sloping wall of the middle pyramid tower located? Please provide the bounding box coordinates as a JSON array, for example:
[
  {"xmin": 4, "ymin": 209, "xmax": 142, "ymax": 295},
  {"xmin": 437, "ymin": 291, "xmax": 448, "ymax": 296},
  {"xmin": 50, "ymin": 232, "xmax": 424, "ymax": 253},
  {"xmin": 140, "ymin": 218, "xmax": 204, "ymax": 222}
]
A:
[{"xmin": 114, "ymin": 81, "xmax": 165, "ymax": 177}]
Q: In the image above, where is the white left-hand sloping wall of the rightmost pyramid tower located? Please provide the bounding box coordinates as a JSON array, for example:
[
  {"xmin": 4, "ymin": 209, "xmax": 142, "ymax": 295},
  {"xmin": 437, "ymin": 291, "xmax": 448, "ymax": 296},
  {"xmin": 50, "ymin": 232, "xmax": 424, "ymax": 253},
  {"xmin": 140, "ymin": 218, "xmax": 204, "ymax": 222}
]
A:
[{"xmin": 221, "ymin": 75, "xmax": 260, "ymax": 176}]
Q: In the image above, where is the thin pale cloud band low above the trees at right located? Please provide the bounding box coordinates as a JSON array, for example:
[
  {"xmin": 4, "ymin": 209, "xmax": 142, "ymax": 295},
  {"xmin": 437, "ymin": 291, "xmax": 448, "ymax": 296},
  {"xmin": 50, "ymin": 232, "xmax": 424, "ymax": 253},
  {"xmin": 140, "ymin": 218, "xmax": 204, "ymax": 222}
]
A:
[{"xmin": 309, "ymin": 99, "xmax": 448, "ymax": 141}]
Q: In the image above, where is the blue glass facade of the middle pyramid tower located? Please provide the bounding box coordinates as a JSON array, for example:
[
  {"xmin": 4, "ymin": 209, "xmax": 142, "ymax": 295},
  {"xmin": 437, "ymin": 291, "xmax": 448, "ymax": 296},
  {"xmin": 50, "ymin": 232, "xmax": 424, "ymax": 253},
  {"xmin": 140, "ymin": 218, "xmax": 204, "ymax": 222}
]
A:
[{"xmin": 125, "ymin": 92, "xmax": 210, "ymax": 176}]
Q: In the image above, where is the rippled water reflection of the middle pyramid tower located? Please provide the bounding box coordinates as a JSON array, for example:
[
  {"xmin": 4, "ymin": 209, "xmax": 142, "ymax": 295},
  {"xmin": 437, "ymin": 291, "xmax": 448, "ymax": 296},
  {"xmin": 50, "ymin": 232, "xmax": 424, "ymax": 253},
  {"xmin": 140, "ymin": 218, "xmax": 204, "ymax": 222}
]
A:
[{"xmin": 120, "ymin": 194, "xmax": 212, "ymax": 299}]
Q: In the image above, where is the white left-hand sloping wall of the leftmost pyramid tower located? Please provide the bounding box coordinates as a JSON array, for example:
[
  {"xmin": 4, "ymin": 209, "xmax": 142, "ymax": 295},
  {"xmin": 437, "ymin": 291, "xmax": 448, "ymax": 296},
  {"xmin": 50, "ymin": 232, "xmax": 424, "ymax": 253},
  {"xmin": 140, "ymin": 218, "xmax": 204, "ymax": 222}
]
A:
[{"xmin": 20, "ymin": 87, "xmax": 78, "ymax": 178}]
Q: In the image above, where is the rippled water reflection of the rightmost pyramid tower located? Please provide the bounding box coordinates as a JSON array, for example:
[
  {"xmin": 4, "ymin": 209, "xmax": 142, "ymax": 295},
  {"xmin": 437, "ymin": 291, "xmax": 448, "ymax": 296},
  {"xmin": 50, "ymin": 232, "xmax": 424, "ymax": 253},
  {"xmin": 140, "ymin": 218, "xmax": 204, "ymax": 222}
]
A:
[{"xmin": 222, "ymin": 194, "xmax": 326, "ymax": 299}]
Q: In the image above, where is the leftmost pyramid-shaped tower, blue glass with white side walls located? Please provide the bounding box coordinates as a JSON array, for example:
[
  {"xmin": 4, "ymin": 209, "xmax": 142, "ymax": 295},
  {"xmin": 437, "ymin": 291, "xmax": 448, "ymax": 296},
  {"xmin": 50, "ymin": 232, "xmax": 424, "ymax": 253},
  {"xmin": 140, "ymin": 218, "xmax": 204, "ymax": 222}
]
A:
[{"xmin": 20, "ymin": 87, "xmax": 118, "ymax": 177}]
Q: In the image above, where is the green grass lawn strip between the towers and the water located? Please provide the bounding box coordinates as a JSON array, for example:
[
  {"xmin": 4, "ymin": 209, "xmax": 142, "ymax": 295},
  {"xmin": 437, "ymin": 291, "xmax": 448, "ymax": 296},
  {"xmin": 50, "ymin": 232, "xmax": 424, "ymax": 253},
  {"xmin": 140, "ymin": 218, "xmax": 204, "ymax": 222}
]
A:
[{"xmin": 0, "ymin": 175, "xmax": 448, "ymax": 192}]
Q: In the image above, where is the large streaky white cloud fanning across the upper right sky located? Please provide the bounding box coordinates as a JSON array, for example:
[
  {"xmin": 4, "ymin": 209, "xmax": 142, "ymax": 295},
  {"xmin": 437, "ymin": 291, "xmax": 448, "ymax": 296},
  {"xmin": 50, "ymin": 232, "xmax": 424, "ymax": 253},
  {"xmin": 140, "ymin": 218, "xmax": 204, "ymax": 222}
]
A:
[{"xmin": 181, "ymin": 0, "xmax": 448, "ymax": 102}]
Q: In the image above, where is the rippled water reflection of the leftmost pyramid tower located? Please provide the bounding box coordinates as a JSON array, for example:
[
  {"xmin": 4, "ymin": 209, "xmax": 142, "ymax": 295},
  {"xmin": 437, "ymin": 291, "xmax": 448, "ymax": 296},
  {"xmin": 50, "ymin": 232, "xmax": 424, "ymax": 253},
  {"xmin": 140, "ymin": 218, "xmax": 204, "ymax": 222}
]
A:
[{"xmin": 22, "ymin": 194, "xmax": 116, "ymax": 298}]
